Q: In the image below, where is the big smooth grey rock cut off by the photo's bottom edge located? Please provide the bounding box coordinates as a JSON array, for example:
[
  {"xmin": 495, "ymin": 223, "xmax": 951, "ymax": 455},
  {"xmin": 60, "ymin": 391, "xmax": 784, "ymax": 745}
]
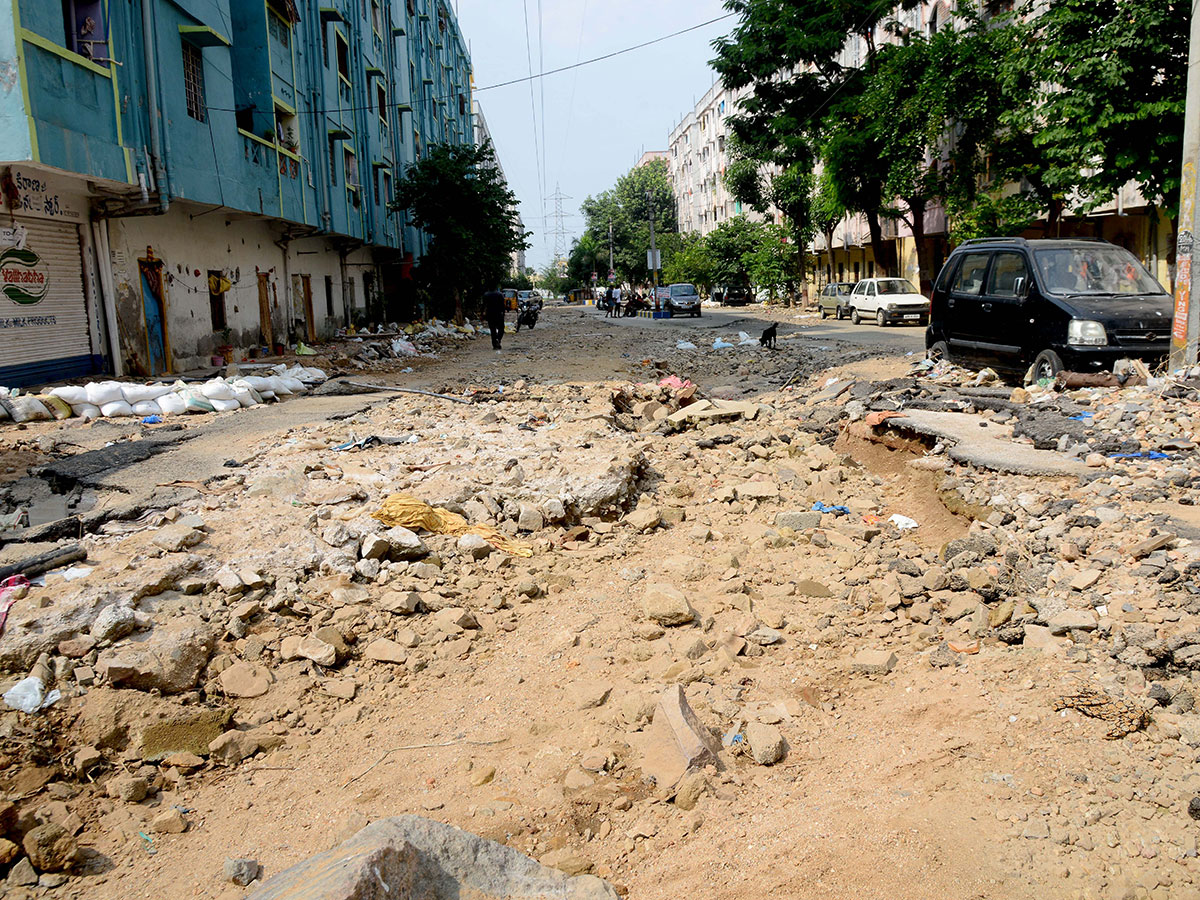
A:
[{"xmin": 247, "ymin": 816, "xmax": 617, "ymax": 900}]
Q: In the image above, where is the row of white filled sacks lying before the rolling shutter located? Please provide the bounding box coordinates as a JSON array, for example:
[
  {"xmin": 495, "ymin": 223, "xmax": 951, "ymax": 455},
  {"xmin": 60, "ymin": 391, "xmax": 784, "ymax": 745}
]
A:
[{"xmin": 0, "ymin": 365, "xmax": 326, "ymax": 425}]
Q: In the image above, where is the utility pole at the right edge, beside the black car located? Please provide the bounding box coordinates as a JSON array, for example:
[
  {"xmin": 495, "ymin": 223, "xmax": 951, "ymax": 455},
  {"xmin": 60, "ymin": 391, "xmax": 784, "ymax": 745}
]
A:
[{"xmin": 1170, "ymin": 0, "xmax": 1200, "ymax": 371}]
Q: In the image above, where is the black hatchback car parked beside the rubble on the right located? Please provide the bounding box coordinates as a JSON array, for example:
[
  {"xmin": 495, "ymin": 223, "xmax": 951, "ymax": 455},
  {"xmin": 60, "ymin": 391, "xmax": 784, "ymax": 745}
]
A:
[{"xmin": 925, "ymin": 238, "xmax": 1174, "ymax": 380}]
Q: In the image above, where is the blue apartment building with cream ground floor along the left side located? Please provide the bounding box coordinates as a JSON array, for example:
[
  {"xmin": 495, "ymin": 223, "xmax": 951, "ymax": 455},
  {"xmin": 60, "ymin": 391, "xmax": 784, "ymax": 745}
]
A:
[{"xmin": 0, "ymin": 0, "xmax": 475, "ymax": 386}]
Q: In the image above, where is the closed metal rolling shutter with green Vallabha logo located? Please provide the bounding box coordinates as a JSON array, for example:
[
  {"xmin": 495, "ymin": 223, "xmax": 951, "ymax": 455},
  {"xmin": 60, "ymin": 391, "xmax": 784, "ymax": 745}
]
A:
[{"xmin": 0, "ymin": 217, "xmax": 92, "ymax": 384}]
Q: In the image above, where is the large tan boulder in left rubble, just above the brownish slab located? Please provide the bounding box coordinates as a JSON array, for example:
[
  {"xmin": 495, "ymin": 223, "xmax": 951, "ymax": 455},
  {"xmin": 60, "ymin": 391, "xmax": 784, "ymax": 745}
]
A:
[{"xmin": 96, "ymin": 616, "xmax": 216, "ymax": 694}]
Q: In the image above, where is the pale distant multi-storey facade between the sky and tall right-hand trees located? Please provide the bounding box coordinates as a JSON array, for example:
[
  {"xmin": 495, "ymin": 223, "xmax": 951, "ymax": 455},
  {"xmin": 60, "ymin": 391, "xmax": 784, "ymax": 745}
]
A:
[{"xmin": 667, "ymin": 80, "xmax": 778, "ymax": 240}]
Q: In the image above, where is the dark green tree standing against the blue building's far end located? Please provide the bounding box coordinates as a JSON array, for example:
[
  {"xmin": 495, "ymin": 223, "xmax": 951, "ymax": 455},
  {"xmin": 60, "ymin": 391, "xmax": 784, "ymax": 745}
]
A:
[{"xmin": 394, "ymin": 143, "xmax": 529, "ymax": 322}]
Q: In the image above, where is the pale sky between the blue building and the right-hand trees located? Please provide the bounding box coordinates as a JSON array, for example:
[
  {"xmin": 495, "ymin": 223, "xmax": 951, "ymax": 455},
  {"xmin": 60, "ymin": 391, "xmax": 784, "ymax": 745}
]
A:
[{"xmin": 452, "ymin": 0, "xmax": 734, "ymax": 269}]
